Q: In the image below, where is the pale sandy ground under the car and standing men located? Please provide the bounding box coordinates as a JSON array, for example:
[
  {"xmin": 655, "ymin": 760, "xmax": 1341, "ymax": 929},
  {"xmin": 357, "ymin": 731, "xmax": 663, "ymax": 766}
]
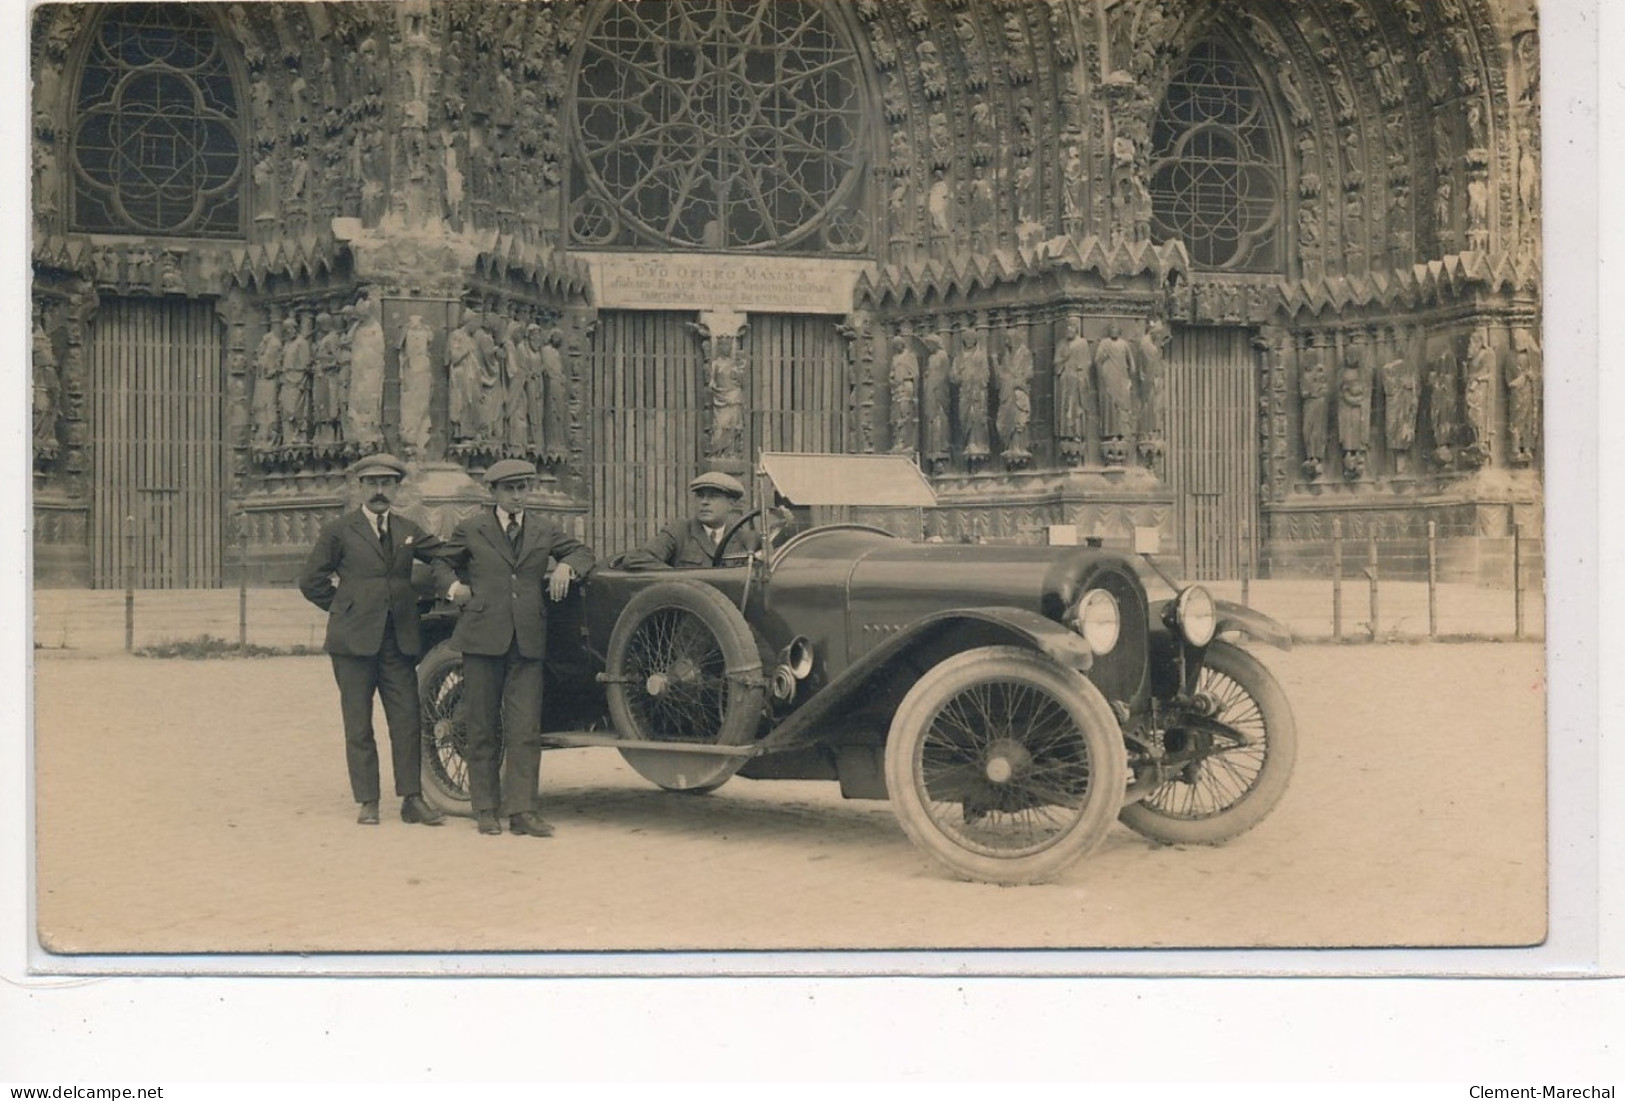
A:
[{"xmin": 34, "ymin": 643, "xmax": 1547, "ymax": 953}]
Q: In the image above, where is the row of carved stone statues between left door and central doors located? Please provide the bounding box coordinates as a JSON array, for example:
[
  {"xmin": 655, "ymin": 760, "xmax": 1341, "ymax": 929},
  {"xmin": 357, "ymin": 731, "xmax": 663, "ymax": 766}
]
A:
[{"xmin": 250, "ymin": 294, "xmax": 569, "ymax": 461}]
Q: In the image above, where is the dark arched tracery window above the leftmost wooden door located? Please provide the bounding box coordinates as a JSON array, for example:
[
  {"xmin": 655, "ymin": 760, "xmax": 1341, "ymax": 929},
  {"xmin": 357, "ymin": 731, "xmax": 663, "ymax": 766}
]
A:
[{"xmin": 73, "ymin": 3, "xmax": 242, "ymax": 237}]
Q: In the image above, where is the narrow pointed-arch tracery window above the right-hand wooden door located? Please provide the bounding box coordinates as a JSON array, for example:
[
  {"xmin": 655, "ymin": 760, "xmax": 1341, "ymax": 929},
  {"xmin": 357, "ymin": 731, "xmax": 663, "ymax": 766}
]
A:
[{"xmin": 1151, "ymin": 41, "xmax": 1282, "ymax": 271}]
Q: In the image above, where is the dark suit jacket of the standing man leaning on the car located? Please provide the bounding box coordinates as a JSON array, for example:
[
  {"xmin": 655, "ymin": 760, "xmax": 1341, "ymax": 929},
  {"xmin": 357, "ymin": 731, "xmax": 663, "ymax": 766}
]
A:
[{"xmin": 436, "ymin": 508, "xmax": 596, "ymax": 659}]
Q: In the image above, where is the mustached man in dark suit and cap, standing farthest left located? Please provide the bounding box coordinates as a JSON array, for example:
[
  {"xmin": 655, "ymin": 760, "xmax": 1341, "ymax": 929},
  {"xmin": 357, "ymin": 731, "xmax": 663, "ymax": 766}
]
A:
[{"xmin": 299, "ymin": 455, "xmax": 444, "ymax": 825}]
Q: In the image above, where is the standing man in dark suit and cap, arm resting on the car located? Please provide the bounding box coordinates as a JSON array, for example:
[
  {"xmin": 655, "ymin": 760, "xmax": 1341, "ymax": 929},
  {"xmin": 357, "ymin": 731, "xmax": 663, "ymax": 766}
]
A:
[{"xmin": 439, "ymin": 460, "xmax": 595, "ymax": 838}]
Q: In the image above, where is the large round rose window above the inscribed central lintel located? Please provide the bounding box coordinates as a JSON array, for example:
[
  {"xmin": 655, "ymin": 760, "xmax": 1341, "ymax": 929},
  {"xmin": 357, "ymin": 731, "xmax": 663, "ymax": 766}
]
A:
[{"xmin": 570, "ymin": 0, "xmax": 868, "ymax": 252}]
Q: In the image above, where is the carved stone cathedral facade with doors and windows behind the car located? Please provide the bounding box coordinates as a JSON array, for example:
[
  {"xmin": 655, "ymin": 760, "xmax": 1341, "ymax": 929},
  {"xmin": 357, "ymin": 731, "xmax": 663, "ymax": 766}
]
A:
[{"xmin": 31, "ymin": 0, "xmax": 1544, "ymax": 586}]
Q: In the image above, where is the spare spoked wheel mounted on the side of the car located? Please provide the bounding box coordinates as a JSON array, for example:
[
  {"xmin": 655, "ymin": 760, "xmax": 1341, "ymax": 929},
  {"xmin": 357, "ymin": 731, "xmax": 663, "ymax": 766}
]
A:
[{"xmin": 605, "ymin": 580, "xmax": 765, "ymax": 794}]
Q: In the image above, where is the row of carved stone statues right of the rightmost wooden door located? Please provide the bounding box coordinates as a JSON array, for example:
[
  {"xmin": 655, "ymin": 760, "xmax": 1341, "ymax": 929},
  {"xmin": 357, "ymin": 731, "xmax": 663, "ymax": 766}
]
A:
[{"xmin": 1298, "ymin": 328, "xmax": 1541, "ymax": 482}]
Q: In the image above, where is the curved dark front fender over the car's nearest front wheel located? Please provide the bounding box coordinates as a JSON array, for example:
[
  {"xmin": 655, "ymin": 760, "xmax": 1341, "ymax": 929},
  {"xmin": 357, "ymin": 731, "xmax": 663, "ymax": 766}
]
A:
[{"xmin": 764, "ymin": 607, "xmax": 1094, "ymax": 750}]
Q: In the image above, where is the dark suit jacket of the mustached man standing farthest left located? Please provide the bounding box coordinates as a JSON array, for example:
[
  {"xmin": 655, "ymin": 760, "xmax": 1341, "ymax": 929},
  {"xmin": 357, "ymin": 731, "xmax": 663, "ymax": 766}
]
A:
[{"xmin": 299, "ymin": 508, "xmax": 445, "ymax": 656}]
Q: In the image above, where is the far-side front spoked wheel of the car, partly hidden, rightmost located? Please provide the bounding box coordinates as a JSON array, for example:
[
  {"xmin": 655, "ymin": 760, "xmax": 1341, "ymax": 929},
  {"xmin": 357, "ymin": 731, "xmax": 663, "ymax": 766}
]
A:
[{"xmin": 1120, "ymin": 641, "xmax": 1298, "ymax": 844}]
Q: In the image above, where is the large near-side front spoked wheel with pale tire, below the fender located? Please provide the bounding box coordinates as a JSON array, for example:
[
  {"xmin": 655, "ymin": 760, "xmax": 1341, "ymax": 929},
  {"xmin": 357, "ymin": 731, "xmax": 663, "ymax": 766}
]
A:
[{"xmin": 886, "ymin": 646, "xmax": 1126, "ymax": 883}]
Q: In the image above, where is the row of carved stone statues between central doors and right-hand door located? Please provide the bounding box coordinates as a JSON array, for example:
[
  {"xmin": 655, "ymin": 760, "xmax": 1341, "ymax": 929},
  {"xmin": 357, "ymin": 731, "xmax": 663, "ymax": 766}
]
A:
[{"xmin": 889, "ymin": 317, "xmax": 1168, "ymax": 473}]
